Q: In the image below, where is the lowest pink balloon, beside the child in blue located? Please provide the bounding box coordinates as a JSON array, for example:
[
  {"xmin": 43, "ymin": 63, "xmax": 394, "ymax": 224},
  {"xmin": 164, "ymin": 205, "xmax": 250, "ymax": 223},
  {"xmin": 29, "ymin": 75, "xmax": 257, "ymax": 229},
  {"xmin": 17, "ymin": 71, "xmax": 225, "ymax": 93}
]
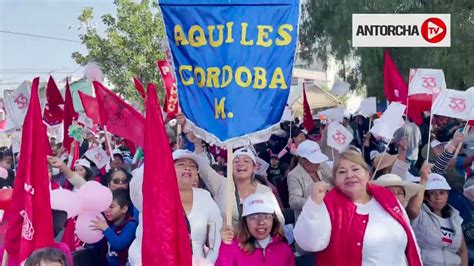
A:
[{"xmin": 76, "ymin": 212, "xmax": 105, "ymax": 244}]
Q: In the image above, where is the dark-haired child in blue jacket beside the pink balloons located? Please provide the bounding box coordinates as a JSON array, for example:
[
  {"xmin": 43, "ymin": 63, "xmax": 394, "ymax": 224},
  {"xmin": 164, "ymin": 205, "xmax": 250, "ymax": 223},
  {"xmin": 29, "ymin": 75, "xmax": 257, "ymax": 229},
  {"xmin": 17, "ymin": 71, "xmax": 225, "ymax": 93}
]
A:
[{"xmin": 91, "ymin": 189, "xmax": 137, "ymax": 266}]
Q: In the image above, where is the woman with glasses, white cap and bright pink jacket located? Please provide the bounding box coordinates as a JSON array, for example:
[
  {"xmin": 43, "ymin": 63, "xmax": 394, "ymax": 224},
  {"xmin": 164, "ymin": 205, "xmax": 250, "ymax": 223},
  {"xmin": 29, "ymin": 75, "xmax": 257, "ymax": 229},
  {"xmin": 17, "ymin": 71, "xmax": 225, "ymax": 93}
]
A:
[{"xmin": 216, "ymin": 193, "xmax": 295, "ymax": 266}]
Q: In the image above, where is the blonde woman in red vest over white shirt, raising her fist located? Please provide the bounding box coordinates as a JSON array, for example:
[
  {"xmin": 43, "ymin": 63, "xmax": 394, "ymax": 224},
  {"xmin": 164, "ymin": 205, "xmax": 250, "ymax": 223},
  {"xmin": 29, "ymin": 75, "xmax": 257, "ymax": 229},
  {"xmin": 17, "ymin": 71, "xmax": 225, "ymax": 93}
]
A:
[{"xmin": 294, "ymin": 151, "xmax": 421, "ymax": 266}]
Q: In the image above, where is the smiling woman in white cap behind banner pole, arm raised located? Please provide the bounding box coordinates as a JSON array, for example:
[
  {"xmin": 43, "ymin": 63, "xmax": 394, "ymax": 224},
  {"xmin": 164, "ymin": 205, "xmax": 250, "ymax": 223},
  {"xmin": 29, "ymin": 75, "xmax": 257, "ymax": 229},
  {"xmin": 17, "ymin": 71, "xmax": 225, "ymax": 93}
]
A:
[{"xmin": 199, "ymin": 148, "xmax": 285, "ymax": 224}]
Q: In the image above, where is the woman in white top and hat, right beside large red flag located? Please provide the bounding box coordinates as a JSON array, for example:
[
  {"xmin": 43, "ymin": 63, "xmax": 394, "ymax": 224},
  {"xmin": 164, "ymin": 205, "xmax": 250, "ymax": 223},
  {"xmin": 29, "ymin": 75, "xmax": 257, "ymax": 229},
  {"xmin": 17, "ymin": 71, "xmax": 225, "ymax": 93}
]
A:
[{"xmin": 173, "ymin": 150, "xmax": 222, "ymax": 263}]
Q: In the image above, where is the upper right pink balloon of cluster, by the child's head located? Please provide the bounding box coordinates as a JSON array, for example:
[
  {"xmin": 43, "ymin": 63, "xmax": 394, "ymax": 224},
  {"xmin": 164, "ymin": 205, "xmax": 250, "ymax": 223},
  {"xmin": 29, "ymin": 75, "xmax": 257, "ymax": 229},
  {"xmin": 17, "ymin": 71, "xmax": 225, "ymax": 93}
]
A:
[{"xmin": 79, "ymin": 181, "xmax": 112, "ymax": 213}]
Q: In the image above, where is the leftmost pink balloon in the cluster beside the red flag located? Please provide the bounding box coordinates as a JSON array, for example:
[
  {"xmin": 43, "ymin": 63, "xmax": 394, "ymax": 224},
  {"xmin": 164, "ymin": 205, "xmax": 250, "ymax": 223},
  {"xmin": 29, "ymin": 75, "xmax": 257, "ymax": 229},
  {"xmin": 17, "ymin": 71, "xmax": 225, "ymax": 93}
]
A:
[{"xmin": 51, "ymin": 189, "xmax": 81, "ymax": 218}]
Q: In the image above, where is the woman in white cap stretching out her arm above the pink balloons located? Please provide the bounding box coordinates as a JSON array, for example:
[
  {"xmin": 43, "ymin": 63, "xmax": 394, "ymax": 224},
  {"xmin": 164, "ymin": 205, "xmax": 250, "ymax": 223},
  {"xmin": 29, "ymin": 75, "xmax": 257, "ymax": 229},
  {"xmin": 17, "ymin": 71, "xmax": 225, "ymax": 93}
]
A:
[{"xmin": 48, "ymin": 156, "xmax": 94, "ymax": 189}]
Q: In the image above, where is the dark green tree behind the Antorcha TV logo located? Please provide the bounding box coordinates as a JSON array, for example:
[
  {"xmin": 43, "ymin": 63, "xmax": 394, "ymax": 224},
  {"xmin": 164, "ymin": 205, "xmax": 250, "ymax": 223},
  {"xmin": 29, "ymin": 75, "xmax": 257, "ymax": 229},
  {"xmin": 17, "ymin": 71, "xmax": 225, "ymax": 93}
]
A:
[{"xmin": 300, "ymin": 0, "xmax": 474, "ymax": 100}]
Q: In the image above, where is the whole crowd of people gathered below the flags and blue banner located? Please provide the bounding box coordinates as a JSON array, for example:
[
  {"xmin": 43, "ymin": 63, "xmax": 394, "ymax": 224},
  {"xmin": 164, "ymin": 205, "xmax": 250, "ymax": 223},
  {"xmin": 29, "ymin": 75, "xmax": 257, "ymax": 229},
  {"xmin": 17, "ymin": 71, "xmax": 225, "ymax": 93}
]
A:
[{"xmin": 0, "ymin": 109, "xmax": 474, "ymax": 266}]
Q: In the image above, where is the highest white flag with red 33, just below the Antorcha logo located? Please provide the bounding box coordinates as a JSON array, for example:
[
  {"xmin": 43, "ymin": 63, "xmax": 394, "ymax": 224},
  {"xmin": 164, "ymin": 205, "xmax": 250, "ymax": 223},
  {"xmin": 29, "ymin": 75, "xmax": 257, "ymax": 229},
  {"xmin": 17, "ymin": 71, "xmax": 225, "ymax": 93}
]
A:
[{"xmin": 408, "ymin": 68, "xmax": 446, "ymax": 96}]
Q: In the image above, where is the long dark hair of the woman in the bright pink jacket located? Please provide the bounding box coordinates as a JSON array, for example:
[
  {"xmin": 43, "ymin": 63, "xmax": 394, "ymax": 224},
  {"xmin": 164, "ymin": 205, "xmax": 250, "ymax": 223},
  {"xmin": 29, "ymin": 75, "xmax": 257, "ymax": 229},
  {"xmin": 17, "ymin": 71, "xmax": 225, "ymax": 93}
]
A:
[{"xmin": 236, "ymin": 214, "xmax": 286, "ymax": 255}]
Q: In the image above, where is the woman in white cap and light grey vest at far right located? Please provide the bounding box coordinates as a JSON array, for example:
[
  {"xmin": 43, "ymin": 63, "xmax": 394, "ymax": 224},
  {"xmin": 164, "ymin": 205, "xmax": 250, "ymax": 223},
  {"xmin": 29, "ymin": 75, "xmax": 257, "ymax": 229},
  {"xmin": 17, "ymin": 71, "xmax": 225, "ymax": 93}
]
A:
[{"xmin": 412, "ymin": 173, "xmax": 468, "ymax": 266}]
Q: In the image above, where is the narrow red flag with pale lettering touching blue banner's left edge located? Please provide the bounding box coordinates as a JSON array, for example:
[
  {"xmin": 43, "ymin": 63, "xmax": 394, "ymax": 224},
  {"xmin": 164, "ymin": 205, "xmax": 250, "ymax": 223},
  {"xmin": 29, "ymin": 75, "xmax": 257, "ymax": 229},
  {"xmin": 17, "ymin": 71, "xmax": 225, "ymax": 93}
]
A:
[{"xmin": 156, "ymin": 60, "xmax": 179, "ymax": 119}]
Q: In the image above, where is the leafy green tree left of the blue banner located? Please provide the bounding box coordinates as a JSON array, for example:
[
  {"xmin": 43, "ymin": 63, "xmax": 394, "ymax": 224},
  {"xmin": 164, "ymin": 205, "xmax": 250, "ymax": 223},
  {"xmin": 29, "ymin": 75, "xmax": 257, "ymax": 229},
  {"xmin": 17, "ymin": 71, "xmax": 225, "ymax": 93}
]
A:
[{"xmin": 72, "ymin": 0, "xmax": 164, "ymax": 102}]
